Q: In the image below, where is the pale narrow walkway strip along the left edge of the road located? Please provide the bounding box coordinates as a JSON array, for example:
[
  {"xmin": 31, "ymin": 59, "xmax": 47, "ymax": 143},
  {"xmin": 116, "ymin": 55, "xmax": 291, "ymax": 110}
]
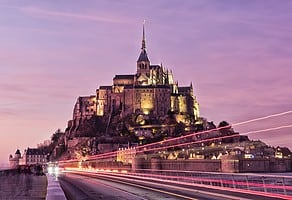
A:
[{"xmin": 46, "ymin": 174, "xmax": 66, "ymax": 200}]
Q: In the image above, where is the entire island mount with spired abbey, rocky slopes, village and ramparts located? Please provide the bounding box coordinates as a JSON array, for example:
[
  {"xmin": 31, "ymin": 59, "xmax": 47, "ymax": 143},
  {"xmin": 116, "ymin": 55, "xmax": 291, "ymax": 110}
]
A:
[{"xmin": 9, "ymin": 25, "xmax": 292, "ymax": 172}]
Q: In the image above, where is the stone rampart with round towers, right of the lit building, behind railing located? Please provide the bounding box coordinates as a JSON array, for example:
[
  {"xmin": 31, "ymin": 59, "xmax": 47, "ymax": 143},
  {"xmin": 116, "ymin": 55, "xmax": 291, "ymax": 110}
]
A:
[{"xmin": 132, "ymin": 157, "xmax": 292, "ymax": 173}]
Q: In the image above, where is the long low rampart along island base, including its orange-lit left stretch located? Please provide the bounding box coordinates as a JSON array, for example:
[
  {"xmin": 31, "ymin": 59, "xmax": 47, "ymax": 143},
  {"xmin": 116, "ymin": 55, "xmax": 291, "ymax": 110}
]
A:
[{"xmin": 77, "ymin": 157, "xmax": 292, "ymax": 173}]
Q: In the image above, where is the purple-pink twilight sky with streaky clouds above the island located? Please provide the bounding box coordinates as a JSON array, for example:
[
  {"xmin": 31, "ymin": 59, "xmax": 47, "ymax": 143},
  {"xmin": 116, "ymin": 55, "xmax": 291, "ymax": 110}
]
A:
[{"xmin": 0, "ymin": 0, "xmax": 292, "ymax": 163}]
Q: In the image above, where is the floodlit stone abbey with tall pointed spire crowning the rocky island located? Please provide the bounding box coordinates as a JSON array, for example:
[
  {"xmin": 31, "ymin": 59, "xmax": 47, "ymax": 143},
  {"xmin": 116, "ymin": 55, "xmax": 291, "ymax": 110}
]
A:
[{"xmin": 73, "ymin": 25, "xmax": 199, "ymax": 125}]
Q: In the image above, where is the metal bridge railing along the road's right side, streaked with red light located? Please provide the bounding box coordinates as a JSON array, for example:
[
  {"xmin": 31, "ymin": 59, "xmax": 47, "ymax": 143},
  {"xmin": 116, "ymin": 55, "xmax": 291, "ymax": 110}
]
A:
[{"xmin": 134, "ymin": 169, "xmax": 292, "ymax": 196}]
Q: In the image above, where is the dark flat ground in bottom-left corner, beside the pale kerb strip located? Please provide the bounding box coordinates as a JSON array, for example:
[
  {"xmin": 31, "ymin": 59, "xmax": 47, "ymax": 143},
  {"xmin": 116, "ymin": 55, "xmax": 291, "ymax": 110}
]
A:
[{"xmin": 0, "ymin": 173, "xmax": 48, "ymax": 200}]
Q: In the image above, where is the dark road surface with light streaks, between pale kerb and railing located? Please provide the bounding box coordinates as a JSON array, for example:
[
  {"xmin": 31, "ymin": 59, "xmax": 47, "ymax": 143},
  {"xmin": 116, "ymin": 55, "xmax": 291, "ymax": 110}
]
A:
[{"xmin": 59, "ymin": 172, "xmax": 284, "ymax": 200}]
